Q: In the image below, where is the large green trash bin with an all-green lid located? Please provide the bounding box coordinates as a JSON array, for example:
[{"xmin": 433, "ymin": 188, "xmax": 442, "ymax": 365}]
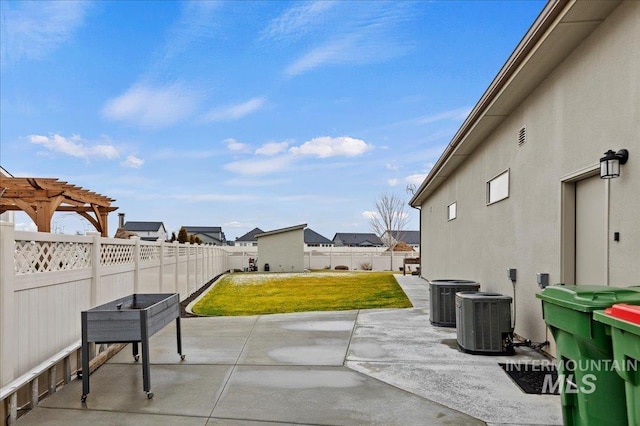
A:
[{"xmin": 536, "ymin": 285, "xmax": 640, "ymax": 426}]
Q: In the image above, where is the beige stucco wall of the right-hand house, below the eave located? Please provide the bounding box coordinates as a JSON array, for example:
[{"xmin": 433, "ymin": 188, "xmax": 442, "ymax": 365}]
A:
[{"xmin": 412, "ymin": 1, "xmax": 640, "ymax": 352}]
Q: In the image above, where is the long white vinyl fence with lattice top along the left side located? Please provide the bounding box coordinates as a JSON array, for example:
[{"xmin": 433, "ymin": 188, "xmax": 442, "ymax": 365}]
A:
[{"xmin": 0, "ymin": 222, "xmax": 229, "ymax": 420}]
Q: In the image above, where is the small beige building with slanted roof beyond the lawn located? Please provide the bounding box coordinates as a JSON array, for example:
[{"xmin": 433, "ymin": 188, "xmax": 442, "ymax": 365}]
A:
[{"xmin": 256, "ymin": 223, "xmax": 307, "ymax": 272}]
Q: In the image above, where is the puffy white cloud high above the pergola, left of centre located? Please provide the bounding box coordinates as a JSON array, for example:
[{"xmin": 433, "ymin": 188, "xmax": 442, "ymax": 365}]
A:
[{"xmin": 102, "ymin": 83, "xmax": 199, "ymax": 128}]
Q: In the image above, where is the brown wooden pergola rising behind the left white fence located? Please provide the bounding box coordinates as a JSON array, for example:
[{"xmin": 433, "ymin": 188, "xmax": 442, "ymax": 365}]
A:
[{"xmin": 0, "ymin": 175, "xmax": 118, "ymax": 237}]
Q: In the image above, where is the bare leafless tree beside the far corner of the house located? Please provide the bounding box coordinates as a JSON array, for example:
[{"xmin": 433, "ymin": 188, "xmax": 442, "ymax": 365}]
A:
[{"xmin": 369, "ymin": 194, "xmax": 409, "ymax": 247}]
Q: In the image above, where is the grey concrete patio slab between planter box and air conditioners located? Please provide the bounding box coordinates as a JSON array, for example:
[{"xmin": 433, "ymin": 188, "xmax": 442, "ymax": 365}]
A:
[{"xmin": 18, "ymin": 275, "xmax": 562, "ymax": 426}]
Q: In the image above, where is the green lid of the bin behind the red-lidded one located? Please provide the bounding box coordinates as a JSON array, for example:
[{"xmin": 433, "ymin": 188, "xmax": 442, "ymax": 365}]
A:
[{"xmin": 536, "ymin": 285, "xmax": 640, "ymax": 312}]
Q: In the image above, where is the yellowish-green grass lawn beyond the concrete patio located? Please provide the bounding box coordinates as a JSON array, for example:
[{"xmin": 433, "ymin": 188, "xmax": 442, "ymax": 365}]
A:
[{"xmin": 193, "ymin": 271, "xmax": 412, "ymax": 316}]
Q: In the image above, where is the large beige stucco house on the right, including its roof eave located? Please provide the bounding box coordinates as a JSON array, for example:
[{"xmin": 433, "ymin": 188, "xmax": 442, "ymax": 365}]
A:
[{"xmin": 410, "ymin": 1, "xmax": 640, "ymax": 353}]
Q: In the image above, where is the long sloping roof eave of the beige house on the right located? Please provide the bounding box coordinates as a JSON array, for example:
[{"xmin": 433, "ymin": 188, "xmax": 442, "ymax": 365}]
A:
[{"xmin": 409, "ymin": 0, "xmax": 621, "ymax": 207}]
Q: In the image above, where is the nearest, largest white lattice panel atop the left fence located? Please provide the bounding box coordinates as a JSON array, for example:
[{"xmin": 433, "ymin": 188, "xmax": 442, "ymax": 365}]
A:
[{"xmin": 14, "ymin": 241, "xmax": 92, "ymax": 274}]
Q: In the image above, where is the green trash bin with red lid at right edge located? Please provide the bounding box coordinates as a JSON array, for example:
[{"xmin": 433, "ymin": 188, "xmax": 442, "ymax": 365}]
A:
[{"xmin": 593, "ymin": 304, "xmax": 640, "ymax": 425}]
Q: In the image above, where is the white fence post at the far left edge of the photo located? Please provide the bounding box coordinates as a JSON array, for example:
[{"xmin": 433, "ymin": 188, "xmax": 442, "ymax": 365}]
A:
[{"xmin": 0, "ymin": 221, "xmax": 17, "ymax": 386}]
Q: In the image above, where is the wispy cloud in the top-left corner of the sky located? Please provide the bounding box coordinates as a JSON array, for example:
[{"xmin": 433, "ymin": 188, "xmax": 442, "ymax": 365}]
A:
[{"xmin": 0, "ymin": 1, "xmax": 91, "ymax": 67}]
